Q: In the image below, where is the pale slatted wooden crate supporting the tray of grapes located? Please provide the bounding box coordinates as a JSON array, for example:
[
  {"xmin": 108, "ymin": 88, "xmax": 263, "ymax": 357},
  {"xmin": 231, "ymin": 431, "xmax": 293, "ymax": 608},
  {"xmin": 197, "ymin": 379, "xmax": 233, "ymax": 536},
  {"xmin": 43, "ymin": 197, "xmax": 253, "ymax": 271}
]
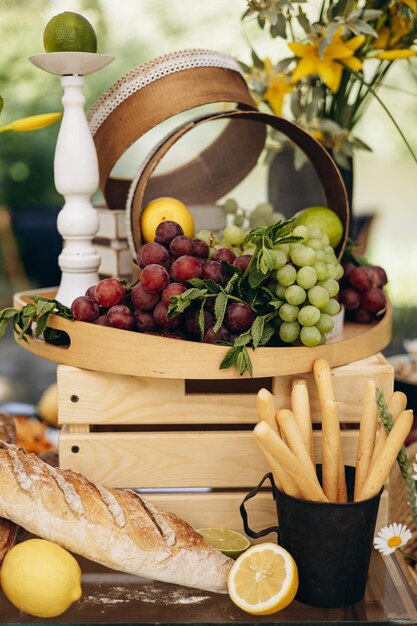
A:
[{"xmin": 58, "ymin": 354, "xmax": 393, "ymax": 529}]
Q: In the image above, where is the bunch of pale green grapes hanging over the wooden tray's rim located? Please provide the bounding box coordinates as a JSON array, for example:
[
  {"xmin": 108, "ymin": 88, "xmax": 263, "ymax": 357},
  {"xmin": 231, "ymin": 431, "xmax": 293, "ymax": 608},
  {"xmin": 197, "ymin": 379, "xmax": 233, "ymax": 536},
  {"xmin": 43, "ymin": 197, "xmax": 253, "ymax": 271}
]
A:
[{"xmin": 196, "ymin": 212, "xmax": 343, "ymax": 358}]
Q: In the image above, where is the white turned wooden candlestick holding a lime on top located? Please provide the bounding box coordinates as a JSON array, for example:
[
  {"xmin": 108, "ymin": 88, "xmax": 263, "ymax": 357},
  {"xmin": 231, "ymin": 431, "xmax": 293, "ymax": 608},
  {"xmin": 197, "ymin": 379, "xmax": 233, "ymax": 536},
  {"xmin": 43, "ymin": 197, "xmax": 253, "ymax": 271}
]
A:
[{"xmin": 30, "ymin": 52, "xmax": 113, "ymax": 306}]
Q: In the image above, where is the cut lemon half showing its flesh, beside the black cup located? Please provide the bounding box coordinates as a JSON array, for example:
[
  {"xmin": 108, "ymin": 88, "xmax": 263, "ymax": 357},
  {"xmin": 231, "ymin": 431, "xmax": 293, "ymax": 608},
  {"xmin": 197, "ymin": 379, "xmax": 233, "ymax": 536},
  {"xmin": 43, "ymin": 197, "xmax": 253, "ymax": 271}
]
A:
[{"xmin": 228, "ymin": 543, "xmax": 298, "ymax": 615}]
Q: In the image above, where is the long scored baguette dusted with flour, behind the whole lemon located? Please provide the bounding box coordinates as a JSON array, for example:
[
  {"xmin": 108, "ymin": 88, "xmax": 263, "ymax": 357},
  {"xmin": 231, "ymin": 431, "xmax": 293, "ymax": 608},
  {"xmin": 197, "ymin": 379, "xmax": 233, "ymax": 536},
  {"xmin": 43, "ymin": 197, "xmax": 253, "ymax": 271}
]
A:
[{"xmin": 0, "ymin": 442, "xmax": 233, "ymax": 592}]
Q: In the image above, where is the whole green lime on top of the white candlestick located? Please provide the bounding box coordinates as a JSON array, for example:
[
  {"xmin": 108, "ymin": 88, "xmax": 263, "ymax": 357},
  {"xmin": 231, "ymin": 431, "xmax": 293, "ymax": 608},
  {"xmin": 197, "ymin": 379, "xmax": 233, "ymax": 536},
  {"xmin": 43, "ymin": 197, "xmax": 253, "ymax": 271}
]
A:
[{"xmin": 43, "ymin": 11, "xmax": 97, "ymax": 52}]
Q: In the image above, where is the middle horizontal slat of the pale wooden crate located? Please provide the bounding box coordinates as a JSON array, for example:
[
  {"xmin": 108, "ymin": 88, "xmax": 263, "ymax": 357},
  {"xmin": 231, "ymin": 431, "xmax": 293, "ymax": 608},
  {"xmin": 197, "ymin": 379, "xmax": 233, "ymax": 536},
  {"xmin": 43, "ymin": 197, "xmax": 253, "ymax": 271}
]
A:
[{"xmin": 59, "ymin": 427, "xmax": 357, "ymax": 489}]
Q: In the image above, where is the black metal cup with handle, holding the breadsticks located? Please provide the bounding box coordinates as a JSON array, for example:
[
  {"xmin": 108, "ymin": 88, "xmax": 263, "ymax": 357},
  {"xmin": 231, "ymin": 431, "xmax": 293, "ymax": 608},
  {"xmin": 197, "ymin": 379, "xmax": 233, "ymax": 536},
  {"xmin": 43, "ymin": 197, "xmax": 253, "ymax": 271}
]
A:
[{"xmin": 240, "ymin": 465, "xmax": 382, "ymax": 608}]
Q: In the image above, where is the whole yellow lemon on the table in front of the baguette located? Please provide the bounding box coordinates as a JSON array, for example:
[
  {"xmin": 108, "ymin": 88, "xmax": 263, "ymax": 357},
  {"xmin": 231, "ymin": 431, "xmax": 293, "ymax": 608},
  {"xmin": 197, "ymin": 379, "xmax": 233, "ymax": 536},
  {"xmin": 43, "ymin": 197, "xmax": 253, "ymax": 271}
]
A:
[{"xmin": 0, "ymin": 539, "xmax": 82, "ymax": 617}]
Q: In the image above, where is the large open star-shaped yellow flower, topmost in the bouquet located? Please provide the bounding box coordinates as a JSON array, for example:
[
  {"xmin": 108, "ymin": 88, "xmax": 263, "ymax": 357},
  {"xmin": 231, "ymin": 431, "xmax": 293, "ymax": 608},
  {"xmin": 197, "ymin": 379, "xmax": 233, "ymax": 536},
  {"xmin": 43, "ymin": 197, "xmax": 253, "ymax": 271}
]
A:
[{"xmin": 288, "ymin": 26, "xmax": 365, "ymax": 93}]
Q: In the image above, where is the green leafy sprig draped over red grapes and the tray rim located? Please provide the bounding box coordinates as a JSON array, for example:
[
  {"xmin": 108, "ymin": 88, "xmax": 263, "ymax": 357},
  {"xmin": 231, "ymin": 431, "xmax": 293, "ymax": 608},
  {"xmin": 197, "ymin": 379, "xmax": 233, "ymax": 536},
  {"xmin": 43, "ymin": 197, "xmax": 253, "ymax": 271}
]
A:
[{"xmin": 167, "ymin": 219, "xmax": 302, "ymax": 376}]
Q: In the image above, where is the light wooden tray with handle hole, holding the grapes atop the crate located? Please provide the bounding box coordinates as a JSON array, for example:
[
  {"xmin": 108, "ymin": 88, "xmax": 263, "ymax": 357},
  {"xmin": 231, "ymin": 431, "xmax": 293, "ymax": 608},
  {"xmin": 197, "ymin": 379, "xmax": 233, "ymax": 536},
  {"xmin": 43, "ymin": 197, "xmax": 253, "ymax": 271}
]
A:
[{"xmin": 14, "ymin": 289, "xmax": 392, "ymax": 380}]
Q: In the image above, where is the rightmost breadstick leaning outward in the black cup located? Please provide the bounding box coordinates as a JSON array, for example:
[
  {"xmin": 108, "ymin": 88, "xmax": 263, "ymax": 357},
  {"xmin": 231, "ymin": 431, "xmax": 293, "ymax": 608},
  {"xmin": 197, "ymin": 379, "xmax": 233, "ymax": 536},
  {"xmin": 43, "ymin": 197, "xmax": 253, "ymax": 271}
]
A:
[{"xmin": 358, "ymin": 410, "xmax": 414, "ymax": 500}]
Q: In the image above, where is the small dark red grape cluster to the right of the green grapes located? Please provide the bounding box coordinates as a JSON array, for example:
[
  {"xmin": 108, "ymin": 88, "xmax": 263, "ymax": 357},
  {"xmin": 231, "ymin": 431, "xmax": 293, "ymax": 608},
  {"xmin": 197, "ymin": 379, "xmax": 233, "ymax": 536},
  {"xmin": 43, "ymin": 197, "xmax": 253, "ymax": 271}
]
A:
[{"xmin": 339, "ymin": 262, "xmax": 388, "ymax": 324}]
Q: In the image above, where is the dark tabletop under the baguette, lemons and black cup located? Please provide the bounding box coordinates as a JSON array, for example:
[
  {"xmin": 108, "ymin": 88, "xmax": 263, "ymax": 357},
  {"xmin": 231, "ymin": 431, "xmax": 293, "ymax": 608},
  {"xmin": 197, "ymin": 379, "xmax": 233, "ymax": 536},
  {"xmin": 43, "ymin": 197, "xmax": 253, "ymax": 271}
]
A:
[{"xmin": 0, "ymin": 552, "xmax": 417, "ymax": 625}]
